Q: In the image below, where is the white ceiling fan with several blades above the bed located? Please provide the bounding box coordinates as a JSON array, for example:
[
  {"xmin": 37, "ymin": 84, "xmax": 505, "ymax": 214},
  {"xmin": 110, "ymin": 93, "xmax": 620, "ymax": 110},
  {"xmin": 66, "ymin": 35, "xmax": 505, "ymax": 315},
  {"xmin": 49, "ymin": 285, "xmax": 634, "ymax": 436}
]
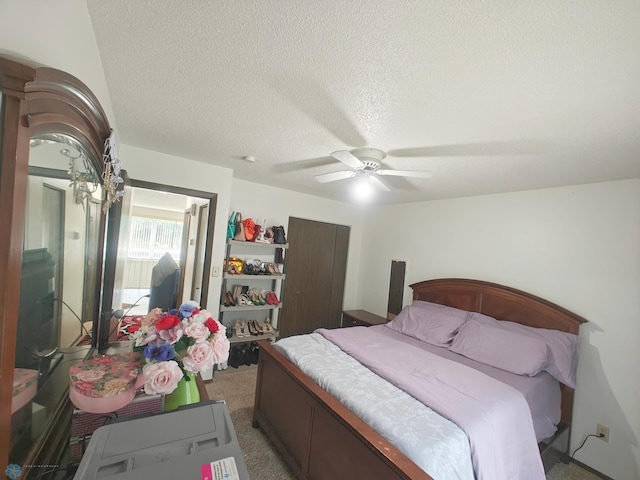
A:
[{"xmin": 313, "ymin": 147, "xmax": 432, "ymax": 192}]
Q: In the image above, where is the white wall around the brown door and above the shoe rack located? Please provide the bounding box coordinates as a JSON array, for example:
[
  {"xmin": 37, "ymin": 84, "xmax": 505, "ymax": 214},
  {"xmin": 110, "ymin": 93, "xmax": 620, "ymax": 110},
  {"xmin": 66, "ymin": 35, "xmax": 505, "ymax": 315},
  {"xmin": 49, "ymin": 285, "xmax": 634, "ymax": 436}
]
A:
[{"xmin": 229, "ymin": 179, "xmax": 363, "ymax": 309}]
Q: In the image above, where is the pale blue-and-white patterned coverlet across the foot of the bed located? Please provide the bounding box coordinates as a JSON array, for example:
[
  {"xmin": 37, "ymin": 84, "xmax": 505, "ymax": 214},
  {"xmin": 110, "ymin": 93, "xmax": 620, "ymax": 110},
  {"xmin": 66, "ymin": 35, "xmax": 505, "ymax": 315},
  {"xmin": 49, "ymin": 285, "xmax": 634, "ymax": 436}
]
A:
[{"xmin": 274, "ymin": 333, "xmax": 475, "ymax": 480}]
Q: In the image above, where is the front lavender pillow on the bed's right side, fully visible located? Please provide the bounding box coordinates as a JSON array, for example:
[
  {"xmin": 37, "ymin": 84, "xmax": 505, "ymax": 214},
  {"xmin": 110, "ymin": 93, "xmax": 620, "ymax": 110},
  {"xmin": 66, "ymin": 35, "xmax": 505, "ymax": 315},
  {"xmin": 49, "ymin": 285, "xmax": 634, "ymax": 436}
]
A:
[{"xmin": 449, "ymin": 319, "xmax": 549, "ymax": 377}]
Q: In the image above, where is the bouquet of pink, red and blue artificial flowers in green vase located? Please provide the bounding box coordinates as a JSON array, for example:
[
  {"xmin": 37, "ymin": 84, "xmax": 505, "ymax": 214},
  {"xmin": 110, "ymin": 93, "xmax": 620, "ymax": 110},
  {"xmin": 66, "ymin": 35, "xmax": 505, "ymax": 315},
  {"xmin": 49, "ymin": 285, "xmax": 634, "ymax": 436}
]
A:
[{"xmin": 130, "ymin": 302, "xmax": 229, "ymax": 395}]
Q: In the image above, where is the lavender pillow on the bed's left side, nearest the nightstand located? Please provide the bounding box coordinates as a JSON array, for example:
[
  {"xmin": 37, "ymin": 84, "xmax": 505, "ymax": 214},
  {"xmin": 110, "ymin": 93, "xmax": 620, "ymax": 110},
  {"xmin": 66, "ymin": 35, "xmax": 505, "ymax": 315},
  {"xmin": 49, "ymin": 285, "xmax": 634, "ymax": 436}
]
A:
[{"xmin": 386, "ymin": 300, "xmax": 469, "ymax": 347}]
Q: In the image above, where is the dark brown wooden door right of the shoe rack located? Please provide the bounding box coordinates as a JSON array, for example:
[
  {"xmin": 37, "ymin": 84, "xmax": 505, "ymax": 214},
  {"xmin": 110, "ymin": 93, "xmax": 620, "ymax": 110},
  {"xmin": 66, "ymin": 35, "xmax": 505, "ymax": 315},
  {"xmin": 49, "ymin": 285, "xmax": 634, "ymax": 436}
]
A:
[{"xmin": 278, "ymin": 217, "xmax": 350, "ymax": 337}]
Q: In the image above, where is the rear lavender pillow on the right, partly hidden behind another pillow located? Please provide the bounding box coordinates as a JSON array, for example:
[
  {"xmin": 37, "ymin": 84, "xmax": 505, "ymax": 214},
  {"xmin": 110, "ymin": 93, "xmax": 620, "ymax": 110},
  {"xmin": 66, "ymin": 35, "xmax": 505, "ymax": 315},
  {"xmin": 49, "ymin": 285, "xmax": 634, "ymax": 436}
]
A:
[{"xmin": 469, "ymin": 312, "xmax": 580, "ymax": 388}]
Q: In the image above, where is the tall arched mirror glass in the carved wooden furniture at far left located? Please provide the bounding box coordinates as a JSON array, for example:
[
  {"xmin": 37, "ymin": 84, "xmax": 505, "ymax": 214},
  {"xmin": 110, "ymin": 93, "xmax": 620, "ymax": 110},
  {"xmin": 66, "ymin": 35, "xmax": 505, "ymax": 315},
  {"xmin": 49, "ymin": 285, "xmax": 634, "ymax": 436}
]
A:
[{"xmin": 11, "ymin": 134, "xmax": 102, "ymax": 462}]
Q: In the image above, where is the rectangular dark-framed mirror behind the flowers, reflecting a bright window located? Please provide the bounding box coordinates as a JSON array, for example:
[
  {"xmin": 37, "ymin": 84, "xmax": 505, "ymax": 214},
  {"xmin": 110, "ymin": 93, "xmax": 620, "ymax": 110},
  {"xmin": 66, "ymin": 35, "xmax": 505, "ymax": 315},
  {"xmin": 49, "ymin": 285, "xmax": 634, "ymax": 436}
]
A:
[{"xmin": 112, "ymin": 184, "xmax": 215, "ymax": 322}]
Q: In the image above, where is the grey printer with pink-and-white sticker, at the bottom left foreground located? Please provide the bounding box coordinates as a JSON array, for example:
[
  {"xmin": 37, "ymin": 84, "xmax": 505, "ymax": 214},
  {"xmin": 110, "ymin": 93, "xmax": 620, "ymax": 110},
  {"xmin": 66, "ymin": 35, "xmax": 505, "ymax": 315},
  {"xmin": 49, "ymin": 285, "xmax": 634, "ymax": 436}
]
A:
[{"xmin": 74, "ymin": 401, "xmax": 249, "ymax": 480}]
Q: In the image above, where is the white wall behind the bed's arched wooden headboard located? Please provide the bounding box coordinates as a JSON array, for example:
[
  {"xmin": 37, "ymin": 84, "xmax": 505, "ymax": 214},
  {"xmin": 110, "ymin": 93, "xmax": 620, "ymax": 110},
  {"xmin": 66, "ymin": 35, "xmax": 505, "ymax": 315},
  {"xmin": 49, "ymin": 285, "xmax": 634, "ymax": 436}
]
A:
[{"xmin": 358, "ymin": 180, "xmax": 640, "ymax": 480}]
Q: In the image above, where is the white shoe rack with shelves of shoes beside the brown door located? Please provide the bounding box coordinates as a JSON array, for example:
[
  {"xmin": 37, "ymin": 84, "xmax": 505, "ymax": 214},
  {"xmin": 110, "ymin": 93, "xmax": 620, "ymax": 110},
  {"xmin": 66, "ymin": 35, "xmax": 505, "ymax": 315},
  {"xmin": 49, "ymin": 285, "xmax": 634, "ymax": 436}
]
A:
[{"xmin": 219, "ymin": 238, "xmax": 289, "ymax": 344}]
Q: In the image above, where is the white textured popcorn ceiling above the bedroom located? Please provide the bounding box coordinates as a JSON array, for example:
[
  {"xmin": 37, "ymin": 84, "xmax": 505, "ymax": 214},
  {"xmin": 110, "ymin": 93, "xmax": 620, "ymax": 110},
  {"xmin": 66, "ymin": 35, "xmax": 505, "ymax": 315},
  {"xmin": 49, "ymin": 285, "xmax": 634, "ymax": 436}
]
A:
[{"xmin": 87, "ymin": 0, "xmax": 640, "ymax": 203}]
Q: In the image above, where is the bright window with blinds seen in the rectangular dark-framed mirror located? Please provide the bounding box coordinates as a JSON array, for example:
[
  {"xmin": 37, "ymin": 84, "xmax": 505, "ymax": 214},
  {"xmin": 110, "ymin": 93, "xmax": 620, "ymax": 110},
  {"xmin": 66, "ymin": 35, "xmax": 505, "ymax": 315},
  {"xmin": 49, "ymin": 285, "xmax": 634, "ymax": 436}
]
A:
[{"xmin": 129, "ymin": 216, "xmax": 182, "ymax": 259}]
